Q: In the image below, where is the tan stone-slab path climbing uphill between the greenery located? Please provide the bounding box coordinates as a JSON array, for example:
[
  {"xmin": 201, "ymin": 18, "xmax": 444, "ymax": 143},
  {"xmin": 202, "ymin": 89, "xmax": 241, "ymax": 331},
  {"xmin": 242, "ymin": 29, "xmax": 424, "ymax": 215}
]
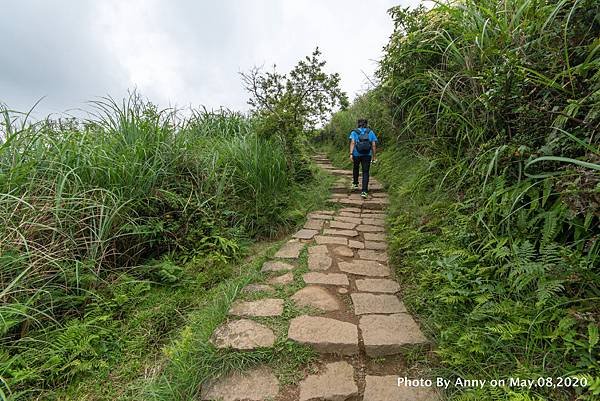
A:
[{"xmin": 200, "ymin": 155, "xmax": 441, "ymax": 401}]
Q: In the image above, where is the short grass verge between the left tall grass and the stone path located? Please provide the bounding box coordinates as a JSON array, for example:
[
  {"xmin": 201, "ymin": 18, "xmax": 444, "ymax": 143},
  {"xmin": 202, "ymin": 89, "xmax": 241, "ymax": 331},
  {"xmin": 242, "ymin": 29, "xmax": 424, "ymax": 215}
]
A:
[{"xmin": 47, "ymin": 164, "xmax": 332, "ymax": 400}]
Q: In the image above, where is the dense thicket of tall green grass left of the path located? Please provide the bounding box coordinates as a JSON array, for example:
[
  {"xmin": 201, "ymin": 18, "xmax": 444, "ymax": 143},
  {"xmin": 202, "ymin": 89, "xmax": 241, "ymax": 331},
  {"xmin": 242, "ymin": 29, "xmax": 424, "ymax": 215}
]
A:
[{"xmin": 0, "ymin": 94, "xmax": 295, "ymax": 399}]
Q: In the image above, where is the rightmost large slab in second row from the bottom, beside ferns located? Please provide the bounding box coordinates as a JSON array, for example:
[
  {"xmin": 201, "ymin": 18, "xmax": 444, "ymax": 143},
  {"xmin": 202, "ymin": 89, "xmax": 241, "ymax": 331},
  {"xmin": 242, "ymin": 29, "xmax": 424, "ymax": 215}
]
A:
[{"xmin": 359, "ymin": 313, "xmax": 428, "ymax": 357}]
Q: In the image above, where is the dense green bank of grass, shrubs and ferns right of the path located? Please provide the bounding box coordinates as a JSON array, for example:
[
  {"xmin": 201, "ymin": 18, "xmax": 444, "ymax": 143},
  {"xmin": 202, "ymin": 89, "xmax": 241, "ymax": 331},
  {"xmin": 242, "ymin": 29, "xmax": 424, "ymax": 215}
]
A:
[{"xmin": 323, "ymin": 0, "xmax": 600, "ymax": 401}]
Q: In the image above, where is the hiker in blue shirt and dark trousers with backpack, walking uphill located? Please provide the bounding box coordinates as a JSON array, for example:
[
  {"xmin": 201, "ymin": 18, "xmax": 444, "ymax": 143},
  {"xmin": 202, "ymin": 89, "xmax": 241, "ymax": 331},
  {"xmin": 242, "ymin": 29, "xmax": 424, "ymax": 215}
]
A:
[{"xmin": 348, "ymin": 118, "xmax": 377, "ymax": 199}]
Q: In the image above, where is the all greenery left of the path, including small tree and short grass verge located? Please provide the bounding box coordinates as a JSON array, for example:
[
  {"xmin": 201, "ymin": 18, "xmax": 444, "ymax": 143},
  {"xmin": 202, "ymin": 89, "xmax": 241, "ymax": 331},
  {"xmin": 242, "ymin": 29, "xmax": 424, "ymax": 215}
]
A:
[{"xmin": 0, "ymin": 49, "xmax": 346, "ymax": 400}]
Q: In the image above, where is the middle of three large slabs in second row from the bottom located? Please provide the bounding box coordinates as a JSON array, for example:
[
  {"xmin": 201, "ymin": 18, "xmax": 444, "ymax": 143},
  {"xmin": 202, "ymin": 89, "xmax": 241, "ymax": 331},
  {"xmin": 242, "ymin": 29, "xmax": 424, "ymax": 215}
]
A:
[{"xmin": 288, "ymin": 315, "xmax": 358, "ymax": 355}]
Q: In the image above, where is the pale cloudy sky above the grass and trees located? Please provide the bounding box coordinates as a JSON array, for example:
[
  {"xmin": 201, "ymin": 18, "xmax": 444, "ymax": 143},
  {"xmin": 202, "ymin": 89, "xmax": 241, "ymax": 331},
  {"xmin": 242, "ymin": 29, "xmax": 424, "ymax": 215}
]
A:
[{"xmin": 0, "ymin": 0, "xmax": 419, "ymax": 116}]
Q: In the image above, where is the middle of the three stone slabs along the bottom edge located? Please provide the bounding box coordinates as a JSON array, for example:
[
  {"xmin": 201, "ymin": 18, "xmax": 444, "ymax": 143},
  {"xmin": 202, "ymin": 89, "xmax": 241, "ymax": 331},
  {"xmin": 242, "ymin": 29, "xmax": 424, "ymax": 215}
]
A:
[{"xmin": 300, "ymin": 361, "xmax": 358, "ymax": 401}]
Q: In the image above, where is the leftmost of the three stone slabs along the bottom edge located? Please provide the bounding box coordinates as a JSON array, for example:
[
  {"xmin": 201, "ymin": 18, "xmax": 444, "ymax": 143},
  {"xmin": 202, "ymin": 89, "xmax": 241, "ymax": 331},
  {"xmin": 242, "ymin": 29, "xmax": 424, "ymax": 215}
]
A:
[{"xmin": 200, "ymin": 367, "xmax": 279, "ymax": 401}]
